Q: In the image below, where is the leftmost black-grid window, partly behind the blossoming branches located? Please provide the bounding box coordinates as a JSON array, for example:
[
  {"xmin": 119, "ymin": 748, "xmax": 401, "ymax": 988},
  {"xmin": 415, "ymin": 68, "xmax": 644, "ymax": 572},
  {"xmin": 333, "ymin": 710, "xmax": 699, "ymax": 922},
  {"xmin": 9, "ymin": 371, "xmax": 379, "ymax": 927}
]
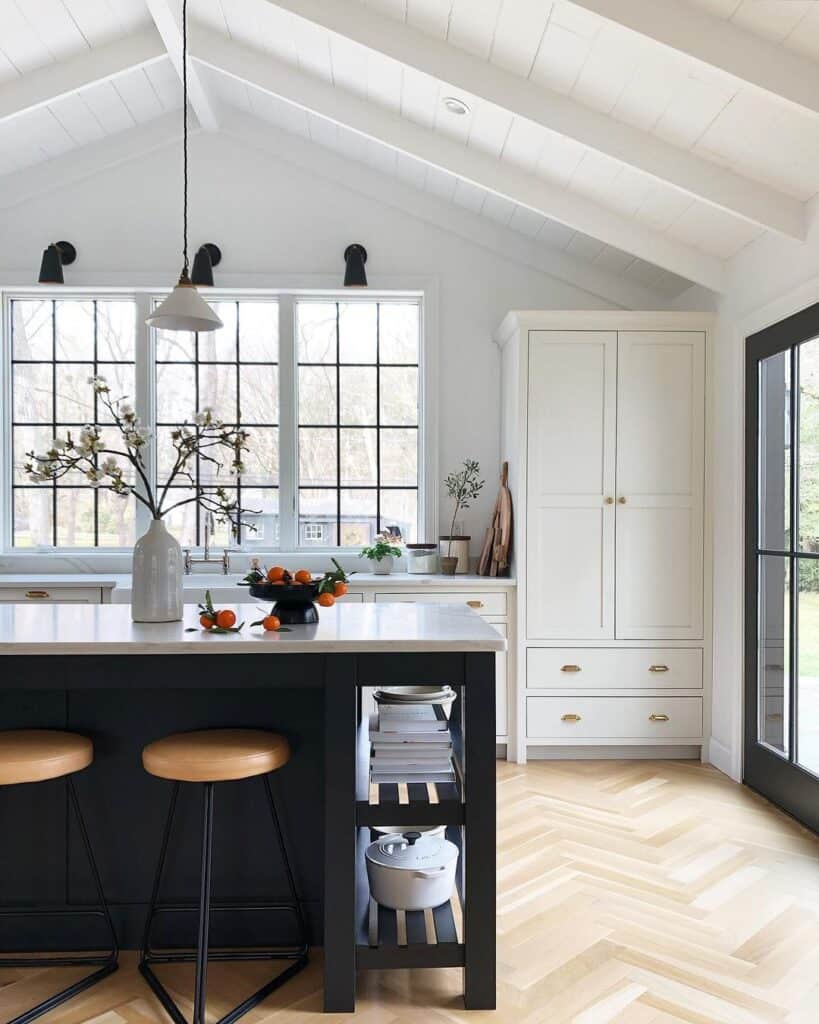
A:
[{"xmin": 10, "ymin": 298, "xmax": 136, "ymax": 548}]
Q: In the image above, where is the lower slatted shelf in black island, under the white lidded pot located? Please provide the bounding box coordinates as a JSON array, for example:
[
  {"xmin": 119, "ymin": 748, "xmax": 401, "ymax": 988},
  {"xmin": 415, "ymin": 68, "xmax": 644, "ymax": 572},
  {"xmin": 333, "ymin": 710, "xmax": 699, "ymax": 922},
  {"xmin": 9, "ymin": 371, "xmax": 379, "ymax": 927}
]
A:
[{"xmin": 355, "ymin": 828, "xmax": 465, "ymax": 970}]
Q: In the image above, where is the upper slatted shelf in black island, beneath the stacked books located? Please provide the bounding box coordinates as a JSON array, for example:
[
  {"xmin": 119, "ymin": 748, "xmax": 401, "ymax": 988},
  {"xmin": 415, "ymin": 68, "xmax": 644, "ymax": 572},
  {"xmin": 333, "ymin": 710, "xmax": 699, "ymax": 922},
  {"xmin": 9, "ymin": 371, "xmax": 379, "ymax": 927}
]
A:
[{"xmin": 355, "ymin": 719, "xmax": 464, "ymax": 826}]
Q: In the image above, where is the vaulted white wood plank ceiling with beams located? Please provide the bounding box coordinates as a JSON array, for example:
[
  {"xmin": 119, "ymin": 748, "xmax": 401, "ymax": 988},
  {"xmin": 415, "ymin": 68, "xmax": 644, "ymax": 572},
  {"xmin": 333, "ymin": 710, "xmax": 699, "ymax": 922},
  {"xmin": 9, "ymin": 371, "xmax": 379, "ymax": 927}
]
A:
[{"xmin": 0, "ymin": 0, "xmax": 819, "ymax": 296}]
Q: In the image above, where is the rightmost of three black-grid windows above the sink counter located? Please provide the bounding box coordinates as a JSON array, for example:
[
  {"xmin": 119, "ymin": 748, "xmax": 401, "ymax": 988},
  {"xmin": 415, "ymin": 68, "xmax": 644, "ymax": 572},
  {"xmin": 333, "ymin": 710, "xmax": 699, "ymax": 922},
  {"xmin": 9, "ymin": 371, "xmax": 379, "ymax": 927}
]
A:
[{"xmin": 296, "ymin": 301, "xmax": 420, "ymax": 548}]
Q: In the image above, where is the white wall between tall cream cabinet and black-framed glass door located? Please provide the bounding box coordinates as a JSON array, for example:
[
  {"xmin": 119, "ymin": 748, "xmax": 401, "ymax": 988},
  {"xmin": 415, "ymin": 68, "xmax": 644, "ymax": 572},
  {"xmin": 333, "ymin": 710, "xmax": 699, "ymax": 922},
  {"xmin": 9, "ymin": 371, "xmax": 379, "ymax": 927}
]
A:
[{"xmin": 675, "ymin": 195, "xmax": 819, "ymax": 779}]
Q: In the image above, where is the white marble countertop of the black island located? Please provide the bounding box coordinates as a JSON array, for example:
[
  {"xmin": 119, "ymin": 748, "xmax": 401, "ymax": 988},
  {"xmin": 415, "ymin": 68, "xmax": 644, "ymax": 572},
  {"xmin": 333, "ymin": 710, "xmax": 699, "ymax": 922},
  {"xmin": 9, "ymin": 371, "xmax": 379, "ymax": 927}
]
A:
[{"xmin": 0, "ymin": 601, "xmax": 506, "ymax": 655}]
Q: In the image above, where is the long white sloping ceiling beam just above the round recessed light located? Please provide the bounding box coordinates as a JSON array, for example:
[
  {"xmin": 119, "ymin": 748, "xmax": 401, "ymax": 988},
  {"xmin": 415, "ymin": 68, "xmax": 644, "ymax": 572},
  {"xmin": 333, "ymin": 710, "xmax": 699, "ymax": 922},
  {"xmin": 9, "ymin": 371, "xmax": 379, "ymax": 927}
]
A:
[{"xmin": 261, "ymin": 0, "xmax": 806, "ymax": 241}]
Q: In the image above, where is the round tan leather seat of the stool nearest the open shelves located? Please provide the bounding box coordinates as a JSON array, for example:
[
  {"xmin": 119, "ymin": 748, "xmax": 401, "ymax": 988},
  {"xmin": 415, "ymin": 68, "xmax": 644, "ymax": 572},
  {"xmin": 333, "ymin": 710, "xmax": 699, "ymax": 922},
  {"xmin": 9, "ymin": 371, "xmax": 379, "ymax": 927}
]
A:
[{"xmin": 142, "ymin": 729, "xmax": 290, "ymax": 782}]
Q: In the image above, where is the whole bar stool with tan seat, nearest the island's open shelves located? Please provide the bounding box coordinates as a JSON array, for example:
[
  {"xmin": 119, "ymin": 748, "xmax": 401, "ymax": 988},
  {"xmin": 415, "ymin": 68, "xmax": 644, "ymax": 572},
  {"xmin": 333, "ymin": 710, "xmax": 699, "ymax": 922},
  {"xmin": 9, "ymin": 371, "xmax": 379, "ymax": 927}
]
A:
[{"xmin": 139, "ymin": 729, "xmax": 307, "ymax": 1024}]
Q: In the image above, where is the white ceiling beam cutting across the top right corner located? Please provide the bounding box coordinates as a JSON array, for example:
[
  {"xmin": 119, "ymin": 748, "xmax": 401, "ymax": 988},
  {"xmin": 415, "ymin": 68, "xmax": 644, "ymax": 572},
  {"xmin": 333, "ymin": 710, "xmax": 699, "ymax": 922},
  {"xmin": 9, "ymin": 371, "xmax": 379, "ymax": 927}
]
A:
[{"xmin": 571, "ymin": 0, "xmax": 819, "ymax": 114}]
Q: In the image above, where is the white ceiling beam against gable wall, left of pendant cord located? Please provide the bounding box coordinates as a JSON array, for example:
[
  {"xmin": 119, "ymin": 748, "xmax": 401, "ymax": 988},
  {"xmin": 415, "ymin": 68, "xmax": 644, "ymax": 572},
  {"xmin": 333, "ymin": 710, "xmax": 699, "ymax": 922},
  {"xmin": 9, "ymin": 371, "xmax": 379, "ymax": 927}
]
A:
[{"xmin": 0, "ymin": 112, "xmax": 191, "ymax": 209}]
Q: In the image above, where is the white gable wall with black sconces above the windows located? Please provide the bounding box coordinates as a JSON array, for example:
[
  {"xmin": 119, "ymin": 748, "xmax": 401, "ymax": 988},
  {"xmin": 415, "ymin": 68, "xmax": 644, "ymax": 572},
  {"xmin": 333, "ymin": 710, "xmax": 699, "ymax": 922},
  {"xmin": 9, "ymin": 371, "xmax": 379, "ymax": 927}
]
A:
[{"xmin": 0, "ymin": 135, "xmax": 611, "ymax": 561}]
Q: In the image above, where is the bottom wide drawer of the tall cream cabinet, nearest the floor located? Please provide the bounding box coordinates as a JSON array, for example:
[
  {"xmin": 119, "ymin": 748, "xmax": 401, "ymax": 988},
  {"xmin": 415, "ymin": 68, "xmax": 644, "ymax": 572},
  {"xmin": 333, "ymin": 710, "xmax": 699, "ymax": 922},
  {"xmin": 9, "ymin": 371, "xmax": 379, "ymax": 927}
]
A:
[{"xmin": 526, "ymin": 696, "xmax": 702, "ymax": 742}]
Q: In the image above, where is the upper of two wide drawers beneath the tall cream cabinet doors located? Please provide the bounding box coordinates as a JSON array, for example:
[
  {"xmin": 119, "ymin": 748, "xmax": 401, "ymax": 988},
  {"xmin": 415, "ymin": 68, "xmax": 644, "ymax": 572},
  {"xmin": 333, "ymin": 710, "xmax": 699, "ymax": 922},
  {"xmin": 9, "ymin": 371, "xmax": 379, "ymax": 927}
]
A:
[{"xmin": 526, "ymin": 647, "xmax": 702, "ymax": 690}]
